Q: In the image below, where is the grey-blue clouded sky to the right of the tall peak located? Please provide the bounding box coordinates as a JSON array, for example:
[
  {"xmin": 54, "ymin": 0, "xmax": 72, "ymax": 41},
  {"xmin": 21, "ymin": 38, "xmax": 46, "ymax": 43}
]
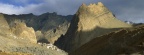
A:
[{"xmin": 100, "ymin": 0, "xmax": 144, "ymax": 23}]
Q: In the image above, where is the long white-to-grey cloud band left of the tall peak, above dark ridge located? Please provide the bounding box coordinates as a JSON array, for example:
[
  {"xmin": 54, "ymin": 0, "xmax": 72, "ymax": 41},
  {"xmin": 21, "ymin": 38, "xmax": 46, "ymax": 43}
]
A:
[{"xmin": 0, "ymin": 0, "xmax": 106, "ymax": 15}]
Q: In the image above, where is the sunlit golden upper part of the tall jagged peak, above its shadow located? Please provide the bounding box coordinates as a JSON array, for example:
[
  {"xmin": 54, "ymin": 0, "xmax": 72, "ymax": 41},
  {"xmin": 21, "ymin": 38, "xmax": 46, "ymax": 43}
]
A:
[{"xmin": 76, "ymin": 2, "xmax": 130, "ymax": 31}]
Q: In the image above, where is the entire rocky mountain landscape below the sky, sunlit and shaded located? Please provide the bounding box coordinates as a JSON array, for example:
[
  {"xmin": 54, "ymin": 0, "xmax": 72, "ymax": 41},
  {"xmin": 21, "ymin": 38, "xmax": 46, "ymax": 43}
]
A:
[{"xmin": 0, "ymin": 2, "xmax": 144, "ymax": 55}]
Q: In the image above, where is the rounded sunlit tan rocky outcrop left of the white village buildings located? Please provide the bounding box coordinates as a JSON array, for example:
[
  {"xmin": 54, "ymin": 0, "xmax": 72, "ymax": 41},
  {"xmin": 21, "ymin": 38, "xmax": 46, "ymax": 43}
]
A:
[{"xmin": 11, "ymin": 21, "xmax": 37, "ymax": 43}]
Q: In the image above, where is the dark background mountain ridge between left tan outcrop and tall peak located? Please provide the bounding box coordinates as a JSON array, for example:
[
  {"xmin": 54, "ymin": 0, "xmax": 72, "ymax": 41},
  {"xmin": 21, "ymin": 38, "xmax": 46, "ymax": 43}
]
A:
[{"xmin": 3, "ymin": 12, "xmax": 73, "ymax": 43}]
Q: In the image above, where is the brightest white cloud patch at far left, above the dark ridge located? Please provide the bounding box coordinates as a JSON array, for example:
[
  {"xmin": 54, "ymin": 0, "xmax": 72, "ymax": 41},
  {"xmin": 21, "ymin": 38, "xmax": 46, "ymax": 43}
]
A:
[{"xmin": 0, "ymin": 3, "xmax": 42, "ymax": 14}]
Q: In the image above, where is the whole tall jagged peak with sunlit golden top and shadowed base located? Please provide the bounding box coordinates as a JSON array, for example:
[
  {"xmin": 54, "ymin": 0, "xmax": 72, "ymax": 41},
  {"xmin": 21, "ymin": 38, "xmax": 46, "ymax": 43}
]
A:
[{"xmin": 55, "ymin": 2, "xmax": 131, "ymax": 52}]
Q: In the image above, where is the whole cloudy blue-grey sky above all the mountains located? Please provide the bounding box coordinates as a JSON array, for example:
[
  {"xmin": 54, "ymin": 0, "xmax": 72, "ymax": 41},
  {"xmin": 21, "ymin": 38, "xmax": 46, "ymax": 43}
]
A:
[{"xmin": 0, "ymin": 0, "xmax": 144, "ymax": 23}]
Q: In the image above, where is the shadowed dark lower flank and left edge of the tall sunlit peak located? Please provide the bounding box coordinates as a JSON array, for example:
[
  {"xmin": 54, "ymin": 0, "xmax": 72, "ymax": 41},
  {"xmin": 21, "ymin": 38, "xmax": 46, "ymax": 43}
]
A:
[{"xmin": 54, "ymin": 15, "xmax": 132, "ymax": 53}]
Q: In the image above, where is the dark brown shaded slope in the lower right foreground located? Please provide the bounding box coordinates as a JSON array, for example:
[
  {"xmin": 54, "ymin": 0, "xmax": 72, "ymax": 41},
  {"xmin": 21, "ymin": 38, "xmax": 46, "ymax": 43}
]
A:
[{"xmin": 69, "ymin": 25, "xmax": 144, "ymax": 55}]
